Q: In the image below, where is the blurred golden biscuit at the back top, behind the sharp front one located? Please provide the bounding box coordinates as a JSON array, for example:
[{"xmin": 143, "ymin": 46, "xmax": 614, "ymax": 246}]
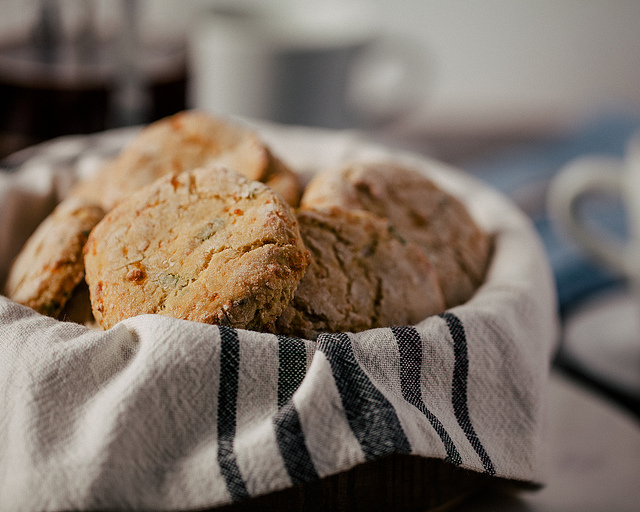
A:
[{"xmin": 71, "ymin": 110, "xmax": 302, "ymax": 211}]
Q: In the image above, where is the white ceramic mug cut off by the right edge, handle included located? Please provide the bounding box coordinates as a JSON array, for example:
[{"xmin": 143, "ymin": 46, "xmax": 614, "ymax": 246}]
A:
[{"xmin": 547, "ymin": 133, "xmax": 640, "ymax": 290}]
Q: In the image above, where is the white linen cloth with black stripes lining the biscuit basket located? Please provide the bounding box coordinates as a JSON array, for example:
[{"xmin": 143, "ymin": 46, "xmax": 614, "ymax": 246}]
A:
[{"xmin": 0, "ymin": 120, "xmax": 558, "ymax": 511}]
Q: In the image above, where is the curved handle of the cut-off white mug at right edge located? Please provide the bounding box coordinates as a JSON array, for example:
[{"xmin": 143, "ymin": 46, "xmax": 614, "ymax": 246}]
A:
[{"xmin": 547, "ymin": 156, "xmax": 627, "ymax": 273}]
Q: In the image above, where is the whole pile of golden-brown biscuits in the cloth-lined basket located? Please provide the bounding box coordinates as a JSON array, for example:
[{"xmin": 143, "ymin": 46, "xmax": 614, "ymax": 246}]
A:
[{"xmin": 6, "ymin": 111, "xmax": 492, "ymax": 339}]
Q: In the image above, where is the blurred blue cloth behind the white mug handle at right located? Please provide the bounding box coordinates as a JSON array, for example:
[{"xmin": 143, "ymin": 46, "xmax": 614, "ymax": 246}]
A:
[{"xmin": 465, "ymin": 112, "xmax": 640, "ymax": 314}]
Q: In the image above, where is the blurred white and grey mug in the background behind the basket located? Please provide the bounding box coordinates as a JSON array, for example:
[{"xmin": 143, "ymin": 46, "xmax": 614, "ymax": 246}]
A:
[{"xmin": 188, "ymin": 2, "xmax": 430, "ymax": 128}]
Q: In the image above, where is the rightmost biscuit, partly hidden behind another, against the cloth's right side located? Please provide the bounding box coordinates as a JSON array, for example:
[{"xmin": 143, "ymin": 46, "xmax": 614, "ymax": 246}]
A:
[{"xmin": 300, "ymin": 162, "xmax": 492, "ymax": 307}]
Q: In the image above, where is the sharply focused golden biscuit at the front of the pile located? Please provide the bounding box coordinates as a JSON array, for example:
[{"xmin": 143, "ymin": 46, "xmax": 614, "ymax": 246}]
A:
[{"xmin": 85, "ymin": 167, "xmax": 309, "ymax": 331}]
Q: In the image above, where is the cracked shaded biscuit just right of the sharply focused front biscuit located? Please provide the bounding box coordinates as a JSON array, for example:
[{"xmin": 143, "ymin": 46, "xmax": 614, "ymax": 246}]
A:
[{"xmin": 276, "ymin": 207, "xmax": 445, "ymax": 339}]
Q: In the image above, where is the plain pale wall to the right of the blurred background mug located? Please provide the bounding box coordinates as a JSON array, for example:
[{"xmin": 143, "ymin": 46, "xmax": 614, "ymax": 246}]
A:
[{"xmin": 370, "ymin": 0, "xmax": 640, "ymax": 134}]
